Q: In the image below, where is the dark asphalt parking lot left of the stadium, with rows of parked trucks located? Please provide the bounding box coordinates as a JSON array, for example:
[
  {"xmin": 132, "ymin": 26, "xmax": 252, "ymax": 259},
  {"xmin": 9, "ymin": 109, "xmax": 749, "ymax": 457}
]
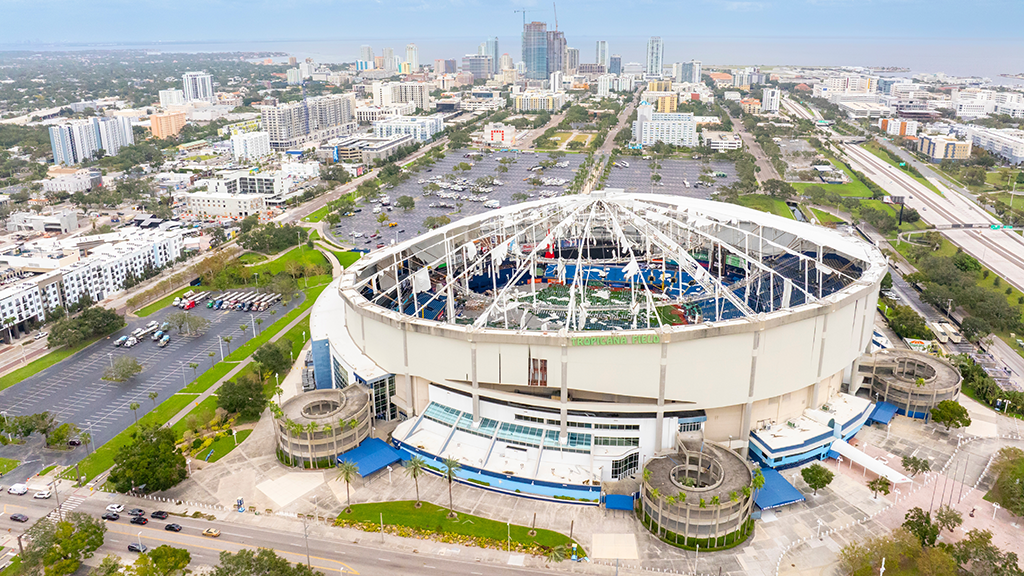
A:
[{"xmin": 0, "ymin": 293, "xmax": 305, "ymax": 450}]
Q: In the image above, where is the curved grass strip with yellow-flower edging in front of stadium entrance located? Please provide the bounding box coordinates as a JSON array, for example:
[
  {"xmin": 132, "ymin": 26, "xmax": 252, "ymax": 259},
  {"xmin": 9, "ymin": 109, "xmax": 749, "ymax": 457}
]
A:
[{"xmin": 338, "ymin": 500, "xmax": 573, "ymax": 547}]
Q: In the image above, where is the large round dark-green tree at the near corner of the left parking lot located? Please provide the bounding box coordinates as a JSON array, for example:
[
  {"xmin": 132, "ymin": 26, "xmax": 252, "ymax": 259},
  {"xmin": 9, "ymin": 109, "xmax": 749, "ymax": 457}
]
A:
[{"xmin": 110, "ymin": 424, "xmax": 185, "ymax": 493}]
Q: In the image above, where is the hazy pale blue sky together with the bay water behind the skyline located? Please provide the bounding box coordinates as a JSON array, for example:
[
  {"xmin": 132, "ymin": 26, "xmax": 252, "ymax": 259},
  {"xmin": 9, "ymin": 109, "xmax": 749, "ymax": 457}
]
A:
[{"xmin": 0, "ymin": 0, "xmax": 1024, "ymax": 74}]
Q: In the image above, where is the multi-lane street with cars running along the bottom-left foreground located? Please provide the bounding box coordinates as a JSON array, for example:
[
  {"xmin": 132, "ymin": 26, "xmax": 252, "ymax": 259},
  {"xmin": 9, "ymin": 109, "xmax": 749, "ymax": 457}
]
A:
[{"xmin": 0, "ymin": 483, "xmax": 561, "ymax": 576}]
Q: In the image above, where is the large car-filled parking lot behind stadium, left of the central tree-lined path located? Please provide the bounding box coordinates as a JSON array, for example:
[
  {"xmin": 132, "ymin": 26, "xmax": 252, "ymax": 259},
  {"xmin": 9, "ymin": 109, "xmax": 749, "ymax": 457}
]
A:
[{"xmin": 331, "ymin": 151, "xmax": 586, "ymax": 242}]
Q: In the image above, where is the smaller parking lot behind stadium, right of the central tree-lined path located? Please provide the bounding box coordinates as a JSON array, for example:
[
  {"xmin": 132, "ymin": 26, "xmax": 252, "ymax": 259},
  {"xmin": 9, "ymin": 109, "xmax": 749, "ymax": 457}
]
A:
[{"xmin": 605, "ymin": 156, "xmax": 738, "ymax": 199}]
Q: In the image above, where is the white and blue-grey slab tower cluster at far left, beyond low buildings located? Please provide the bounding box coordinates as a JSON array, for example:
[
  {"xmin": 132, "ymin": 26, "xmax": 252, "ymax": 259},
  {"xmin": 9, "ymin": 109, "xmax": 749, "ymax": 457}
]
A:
[{"xmin": 50, "ymin": 117, "xmax": 135, "ymax": 166}]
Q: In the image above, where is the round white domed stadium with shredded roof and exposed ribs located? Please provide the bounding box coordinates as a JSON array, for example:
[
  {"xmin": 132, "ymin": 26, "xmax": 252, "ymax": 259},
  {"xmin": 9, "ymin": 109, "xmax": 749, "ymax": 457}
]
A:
[{"xmin": 311, "ymin": 191, "xmax": 886, "ymax": 501}]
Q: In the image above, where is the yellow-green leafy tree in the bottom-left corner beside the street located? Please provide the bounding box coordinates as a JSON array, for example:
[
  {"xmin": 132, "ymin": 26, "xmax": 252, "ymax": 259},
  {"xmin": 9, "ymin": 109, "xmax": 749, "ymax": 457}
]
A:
[{"xmin": 22, "ymin": 512, "xmax": 106, "ymax": 576}]
